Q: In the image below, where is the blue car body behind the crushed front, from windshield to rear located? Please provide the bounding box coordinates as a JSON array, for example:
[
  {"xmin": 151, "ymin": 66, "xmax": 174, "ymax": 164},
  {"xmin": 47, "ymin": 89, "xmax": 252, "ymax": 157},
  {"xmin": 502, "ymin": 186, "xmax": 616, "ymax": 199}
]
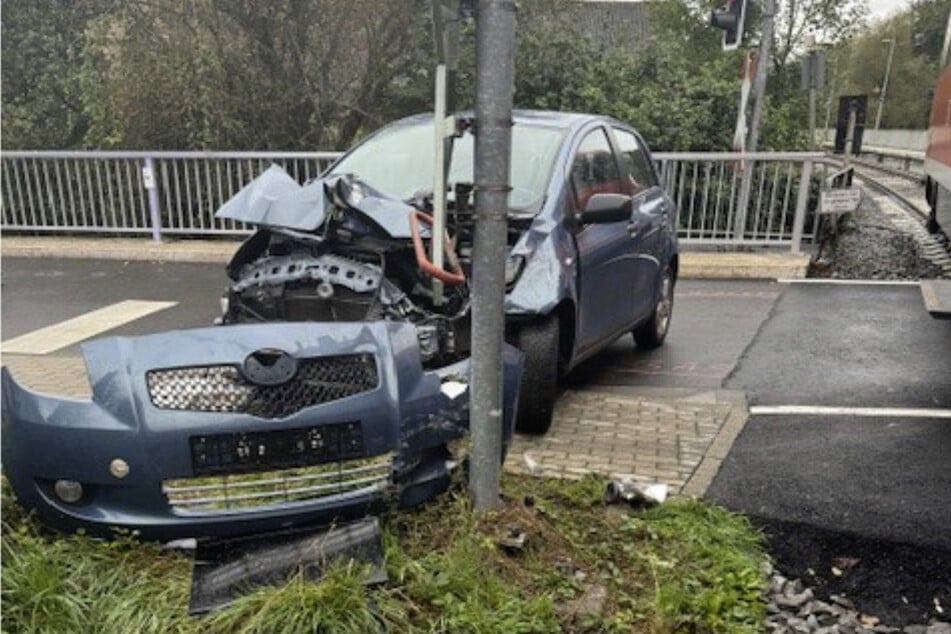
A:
[{"xmin": 326, "ymin": 111, "xmax": 679, "ymax": 433}]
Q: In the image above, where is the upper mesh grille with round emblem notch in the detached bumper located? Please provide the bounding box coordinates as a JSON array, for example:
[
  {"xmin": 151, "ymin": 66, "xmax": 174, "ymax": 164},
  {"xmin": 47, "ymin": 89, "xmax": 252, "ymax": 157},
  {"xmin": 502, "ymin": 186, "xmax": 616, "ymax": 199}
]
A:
[{"xmin": 146, "ymin": 354, "xmax": 379, "ymax": 418}]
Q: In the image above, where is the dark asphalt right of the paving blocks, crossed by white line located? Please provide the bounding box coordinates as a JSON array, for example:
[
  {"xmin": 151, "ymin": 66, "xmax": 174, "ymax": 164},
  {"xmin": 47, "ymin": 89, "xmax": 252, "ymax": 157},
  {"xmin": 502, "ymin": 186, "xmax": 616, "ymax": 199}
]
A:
[{"xmin": 707, "ymin": 284, "xmax": 951, "ymax": 626}]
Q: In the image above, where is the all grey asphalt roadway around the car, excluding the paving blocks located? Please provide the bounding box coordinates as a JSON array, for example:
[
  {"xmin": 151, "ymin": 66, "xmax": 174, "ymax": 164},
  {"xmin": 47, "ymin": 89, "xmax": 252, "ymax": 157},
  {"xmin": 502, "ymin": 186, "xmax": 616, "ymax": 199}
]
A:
[{"xmin": 0, "ymin": 258, "xmax": 951, "ymax": 624}]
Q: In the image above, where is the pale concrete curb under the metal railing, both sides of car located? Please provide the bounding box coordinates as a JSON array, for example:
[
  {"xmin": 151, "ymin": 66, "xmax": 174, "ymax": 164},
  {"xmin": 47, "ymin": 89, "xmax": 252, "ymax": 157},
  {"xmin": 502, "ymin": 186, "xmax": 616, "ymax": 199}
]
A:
[{"xmin": 0, "ymin": 236, "xmax": 809, "ymax": 280}]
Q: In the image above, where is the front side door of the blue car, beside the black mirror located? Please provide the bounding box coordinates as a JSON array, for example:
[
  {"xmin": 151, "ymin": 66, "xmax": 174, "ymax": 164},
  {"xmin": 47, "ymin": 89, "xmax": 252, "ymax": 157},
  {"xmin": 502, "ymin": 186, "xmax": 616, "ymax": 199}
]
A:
[{"xmin": 571, "ymin": 126, "xmax": 636, "ymax": 356}]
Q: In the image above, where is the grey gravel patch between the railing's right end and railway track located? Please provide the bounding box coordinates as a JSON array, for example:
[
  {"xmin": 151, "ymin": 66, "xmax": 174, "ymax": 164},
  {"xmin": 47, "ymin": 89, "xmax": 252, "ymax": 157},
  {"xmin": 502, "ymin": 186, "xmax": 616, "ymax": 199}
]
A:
[{"xmin": 809, "ymin": 188, "xmax": 942, "ymax": 280}]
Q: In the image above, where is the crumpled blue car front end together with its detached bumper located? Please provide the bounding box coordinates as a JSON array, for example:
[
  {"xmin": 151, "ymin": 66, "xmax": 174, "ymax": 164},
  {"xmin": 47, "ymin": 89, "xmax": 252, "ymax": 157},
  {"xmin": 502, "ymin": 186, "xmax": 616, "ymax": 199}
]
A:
[{"xmin": 0, "ymin": 160, "xmax": 521, "ymax": 540}]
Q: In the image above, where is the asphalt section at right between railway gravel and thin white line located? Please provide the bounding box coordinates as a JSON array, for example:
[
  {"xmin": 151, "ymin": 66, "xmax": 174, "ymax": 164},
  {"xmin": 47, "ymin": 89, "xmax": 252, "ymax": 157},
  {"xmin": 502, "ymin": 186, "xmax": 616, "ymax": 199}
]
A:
[{"xmin": 727, "ymin": 284, "xmax": 951, "ymax": 408}]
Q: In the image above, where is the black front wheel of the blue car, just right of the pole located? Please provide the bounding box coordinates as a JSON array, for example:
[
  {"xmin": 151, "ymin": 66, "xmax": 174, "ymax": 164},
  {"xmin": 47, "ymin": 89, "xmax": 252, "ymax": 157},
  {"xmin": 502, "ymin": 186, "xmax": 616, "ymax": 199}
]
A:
[{"xmin": 515, "ymin": 315, "xmax": 559, "ymax": 434}]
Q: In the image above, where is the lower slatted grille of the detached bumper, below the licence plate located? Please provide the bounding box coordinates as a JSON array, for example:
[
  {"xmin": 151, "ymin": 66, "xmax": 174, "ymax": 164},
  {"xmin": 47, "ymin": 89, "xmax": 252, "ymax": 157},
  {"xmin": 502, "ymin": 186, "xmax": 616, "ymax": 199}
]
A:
[{"xmin": 162, "ymin": 453, "xmax": 393, "ymax": 515}]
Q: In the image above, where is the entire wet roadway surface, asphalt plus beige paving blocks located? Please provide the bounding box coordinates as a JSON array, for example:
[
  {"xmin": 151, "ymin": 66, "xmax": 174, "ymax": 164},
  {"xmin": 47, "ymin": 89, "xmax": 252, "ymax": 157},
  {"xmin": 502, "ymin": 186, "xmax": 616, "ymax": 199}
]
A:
[{"xmin": 2, "ymin": 253, "xmax": 951, "ymax": 621}]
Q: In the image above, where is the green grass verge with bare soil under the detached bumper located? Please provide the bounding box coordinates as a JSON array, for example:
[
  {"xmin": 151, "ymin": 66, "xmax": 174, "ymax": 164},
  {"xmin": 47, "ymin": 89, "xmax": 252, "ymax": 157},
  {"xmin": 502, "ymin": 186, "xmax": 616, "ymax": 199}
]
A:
[{"xmin": 0, "ymin": 476, "xmax": 765, "ymax": 634}]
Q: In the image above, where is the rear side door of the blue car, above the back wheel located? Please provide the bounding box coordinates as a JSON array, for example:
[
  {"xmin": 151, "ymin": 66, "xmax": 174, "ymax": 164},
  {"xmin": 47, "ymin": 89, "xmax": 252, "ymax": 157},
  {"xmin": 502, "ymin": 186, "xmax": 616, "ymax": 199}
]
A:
[{"xmin": 612, "ymin": 126, "xmax": 670, "ymax": 321}]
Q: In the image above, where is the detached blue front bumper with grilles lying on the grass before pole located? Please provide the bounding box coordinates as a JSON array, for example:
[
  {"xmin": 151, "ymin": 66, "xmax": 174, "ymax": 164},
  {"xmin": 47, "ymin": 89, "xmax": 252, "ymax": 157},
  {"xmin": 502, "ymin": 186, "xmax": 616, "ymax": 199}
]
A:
[{"xmin": 0, "ymin": 322, "xmax": 521, "ymax": 539}]
